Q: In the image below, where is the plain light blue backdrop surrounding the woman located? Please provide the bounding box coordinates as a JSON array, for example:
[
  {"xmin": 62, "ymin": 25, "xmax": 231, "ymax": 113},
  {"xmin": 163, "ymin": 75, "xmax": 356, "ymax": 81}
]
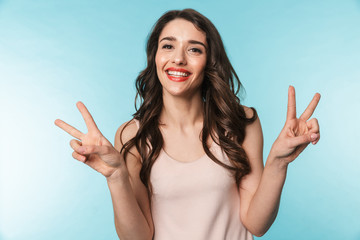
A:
[{"xmin": 0, "ymin": 0, "xmax": 360, "ymax": 240}]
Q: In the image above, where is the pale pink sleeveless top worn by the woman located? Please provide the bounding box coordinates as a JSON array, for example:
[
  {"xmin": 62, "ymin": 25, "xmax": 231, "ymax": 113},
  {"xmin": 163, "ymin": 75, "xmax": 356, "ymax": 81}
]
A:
[{"xmin": 135, "ymin": 120, "xmax": 253, "ymax": 240}]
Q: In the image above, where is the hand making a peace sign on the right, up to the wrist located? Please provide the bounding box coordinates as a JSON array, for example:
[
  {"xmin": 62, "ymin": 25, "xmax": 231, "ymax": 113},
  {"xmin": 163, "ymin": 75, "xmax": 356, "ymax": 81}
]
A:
[{"xmin": 270, "ymin": 86, "xmax": 320, "ymax": 164}]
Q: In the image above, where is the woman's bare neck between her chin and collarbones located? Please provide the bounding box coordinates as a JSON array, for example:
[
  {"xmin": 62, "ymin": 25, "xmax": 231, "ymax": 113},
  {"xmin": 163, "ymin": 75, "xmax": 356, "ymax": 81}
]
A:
[{"xmin": 160, "ymin": 92, "xmax": 204, "ymax": 129}]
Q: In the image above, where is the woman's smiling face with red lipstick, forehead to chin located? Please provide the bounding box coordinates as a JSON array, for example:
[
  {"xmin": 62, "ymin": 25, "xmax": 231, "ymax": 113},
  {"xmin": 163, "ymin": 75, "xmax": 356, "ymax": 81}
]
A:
[{"xmin": 155, "ymin": 19, "xmax": 207, "ymax": 97}]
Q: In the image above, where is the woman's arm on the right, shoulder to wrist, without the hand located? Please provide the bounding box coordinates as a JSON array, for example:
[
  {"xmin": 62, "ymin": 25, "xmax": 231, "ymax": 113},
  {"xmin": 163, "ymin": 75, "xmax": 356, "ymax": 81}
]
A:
[{"xmin": 240, "ymin": 116, "xmax": 286, "ymax": 237}]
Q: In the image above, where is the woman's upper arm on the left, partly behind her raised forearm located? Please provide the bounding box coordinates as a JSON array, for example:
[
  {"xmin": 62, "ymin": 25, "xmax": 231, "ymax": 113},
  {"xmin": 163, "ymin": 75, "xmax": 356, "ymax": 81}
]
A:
[{"xmin": 114, "ymin": 120, "xmax": 154, "ymax": 231}]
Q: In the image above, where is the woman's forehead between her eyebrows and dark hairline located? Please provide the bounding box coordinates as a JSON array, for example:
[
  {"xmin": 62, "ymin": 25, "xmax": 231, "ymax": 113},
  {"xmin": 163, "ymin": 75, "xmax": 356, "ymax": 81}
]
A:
[{"xmin": 159, "ymin": 18, "xmax": 206, "ymax": 44}]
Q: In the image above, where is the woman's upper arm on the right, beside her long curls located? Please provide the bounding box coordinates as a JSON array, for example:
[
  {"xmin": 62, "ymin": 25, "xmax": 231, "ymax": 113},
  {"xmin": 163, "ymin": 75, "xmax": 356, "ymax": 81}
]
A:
[{"xmin": 239, "ymin": 107, "xmax": 264, "ymax": 223}]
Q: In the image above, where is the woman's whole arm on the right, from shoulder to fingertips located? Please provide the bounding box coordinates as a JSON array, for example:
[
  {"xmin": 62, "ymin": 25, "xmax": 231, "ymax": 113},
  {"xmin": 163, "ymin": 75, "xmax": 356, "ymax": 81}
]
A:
[{"xmin": 240, "ymin": 87, "xmax": 320, "ymax": 236}]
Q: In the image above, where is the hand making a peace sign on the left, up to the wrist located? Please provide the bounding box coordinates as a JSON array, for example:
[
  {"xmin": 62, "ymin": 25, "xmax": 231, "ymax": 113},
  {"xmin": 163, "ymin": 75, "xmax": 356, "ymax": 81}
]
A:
[{"xmin": 55, "ymin": 102, "xmax": 123, "ymax": 178}]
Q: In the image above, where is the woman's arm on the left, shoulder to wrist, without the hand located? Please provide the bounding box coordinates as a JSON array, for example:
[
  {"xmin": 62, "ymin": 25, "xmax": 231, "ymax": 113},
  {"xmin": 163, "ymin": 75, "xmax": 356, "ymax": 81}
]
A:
[{"xmin": 107, "ymin": 121, "xmax": 154, "ymax": 240}]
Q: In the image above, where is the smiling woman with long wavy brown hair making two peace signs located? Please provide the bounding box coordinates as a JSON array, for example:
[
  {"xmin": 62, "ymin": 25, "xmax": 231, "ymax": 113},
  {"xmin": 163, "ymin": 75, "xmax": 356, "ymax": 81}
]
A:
[{"xmin": 55, "ymin": 9, "xmax": 320, "ymax": 240}]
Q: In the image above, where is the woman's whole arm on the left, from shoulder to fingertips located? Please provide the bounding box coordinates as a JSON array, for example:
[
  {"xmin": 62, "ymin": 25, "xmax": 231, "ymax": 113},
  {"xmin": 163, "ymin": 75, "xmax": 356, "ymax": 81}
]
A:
[{"xmin": 55, "ymin": 102, "xmax": 154, "ymax": 240}]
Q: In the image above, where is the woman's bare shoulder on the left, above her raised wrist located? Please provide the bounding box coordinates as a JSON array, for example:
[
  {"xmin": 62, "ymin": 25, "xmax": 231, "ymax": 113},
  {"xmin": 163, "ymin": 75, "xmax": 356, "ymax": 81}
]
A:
[{"xmin": 114, "ymin": 119, "xmax": 138, "ymax": 151}]
